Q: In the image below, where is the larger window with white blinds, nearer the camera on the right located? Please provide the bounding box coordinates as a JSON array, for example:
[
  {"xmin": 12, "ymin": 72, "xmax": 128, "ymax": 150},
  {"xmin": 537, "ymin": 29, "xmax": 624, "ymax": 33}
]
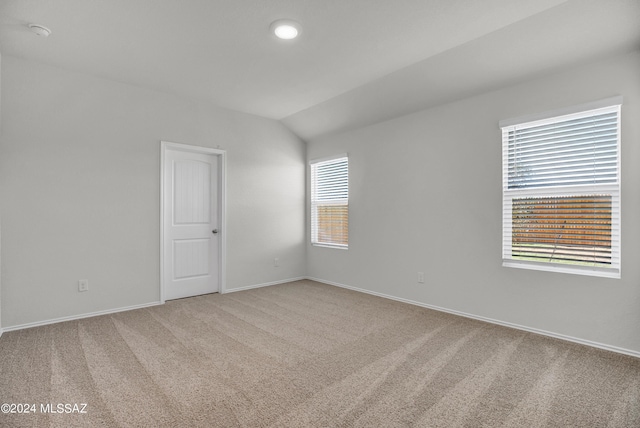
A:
[{"xmin": 500, "ymin": 98, "xmax": 621, "ymax": 278}]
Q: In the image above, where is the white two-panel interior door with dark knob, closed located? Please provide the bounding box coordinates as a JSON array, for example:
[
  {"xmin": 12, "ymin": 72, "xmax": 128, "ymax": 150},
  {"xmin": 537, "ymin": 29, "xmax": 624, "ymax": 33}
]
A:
[{"xmin": 163, "ymin": 148, "xmax": 220, "ymax": 300}]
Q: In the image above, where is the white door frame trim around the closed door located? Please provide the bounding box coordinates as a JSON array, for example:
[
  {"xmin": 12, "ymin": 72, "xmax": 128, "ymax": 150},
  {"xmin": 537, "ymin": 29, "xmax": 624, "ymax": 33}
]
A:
[{"xmin": 160, "ymin": 141, "xmax": 227, "ymax": 303}]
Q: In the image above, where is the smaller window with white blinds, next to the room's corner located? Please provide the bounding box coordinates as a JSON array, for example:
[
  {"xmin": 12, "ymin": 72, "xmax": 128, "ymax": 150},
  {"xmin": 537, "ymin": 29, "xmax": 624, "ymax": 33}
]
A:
[{"xmin": 311, "ymin": 155, "xmax": 349, "ymax": 249}]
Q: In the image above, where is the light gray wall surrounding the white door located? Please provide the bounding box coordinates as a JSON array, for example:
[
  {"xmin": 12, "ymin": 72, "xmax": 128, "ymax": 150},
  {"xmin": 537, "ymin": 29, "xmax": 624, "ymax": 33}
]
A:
[{"xmin": 0, "ymin": 56, "xmax": 306, "ymax": 328}]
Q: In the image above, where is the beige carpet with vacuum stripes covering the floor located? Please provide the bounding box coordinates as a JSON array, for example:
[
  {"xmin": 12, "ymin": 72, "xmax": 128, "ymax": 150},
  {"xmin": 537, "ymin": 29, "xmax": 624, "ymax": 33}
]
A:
[{"xmin": 0, "ymin": 281, "xmax": 640, "ymax": 428}]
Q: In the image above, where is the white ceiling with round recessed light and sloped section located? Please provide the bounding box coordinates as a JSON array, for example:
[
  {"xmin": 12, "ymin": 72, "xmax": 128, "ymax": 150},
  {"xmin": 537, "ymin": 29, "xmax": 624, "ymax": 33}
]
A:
[{"xmin": 0, "ymin": 0, "xmax": 640, "ymax": 139}]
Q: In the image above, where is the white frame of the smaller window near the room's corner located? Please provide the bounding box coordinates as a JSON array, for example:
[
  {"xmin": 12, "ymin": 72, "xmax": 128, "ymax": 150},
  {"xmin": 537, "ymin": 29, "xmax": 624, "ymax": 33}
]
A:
[{"xmin": 309, "ymin": 153, "xmax": 349, "ymax": 250}]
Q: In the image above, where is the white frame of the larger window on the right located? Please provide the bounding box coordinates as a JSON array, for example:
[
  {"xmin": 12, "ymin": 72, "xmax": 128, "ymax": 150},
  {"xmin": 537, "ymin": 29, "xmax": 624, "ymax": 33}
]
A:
[{"xmin": 499, "ymin": 97, "xmax": 622, "ymax": 278}]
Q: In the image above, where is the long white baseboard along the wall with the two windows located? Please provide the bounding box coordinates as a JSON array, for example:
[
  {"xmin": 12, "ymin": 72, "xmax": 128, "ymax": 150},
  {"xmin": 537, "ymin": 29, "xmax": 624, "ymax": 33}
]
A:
[{"xmin": 306, "ymin": 277, "xmax": 640, "ymax": 358}]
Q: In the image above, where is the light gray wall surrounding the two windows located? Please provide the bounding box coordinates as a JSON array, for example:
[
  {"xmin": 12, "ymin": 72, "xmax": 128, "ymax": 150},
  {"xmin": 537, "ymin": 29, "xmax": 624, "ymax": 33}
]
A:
[{"xmin": 307, "ymin": 48, "xmax": 640, "ymax": 352}]
